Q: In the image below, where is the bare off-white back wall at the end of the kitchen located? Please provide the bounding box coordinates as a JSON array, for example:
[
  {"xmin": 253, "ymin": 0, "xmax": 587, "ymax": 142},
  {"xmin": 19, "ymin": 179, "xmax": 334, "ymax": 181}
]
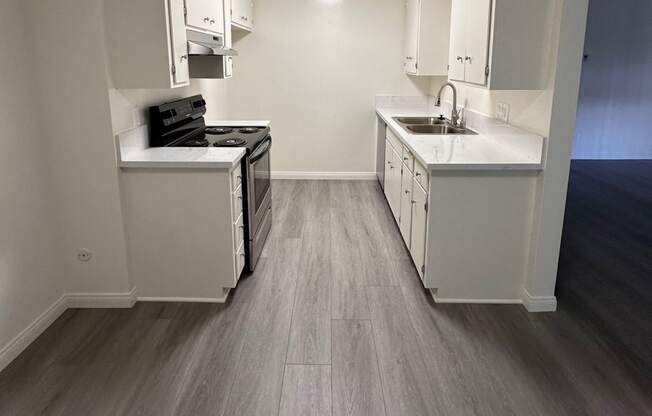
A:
[{"xmin": 228, "ymin": 0, "xmax": 438, "ymax": 172}]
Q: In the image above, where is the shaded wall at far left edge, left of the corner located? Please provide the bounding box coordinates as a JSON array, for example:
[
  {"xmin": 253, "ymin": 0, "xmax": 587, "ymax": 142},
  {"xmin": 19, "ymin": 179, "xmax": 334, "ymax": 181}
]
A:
[{"xmin": 0, "ymin": 0, "xmax": 63, "ymax": 358}]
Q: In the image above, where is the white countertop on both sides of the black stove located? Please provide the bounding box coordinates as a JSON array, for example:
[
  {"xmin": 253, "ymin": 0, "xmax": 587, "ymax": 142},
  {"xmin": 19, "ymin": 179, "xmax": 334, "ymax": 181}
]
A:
[{"xmin": 117, "ymin": 120, "xmax": 270, "ymax": 169}]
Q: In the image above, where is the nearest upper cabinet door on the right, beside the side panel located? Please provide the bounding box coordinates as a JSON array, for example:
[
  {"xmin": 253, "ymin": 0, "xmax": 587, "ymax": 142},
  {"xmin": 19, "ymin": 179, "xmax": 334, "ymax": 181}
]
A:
[{"xmin": 464, "ymin": 0, "xmax": 491, "ymax": 85}]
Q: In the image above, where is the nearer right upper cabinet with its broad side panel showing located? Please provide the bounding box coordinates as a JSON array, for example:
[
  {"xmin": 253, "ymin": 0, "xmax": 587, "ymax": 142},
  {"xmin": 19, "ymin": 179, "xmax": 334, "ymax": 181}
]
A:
[{"xmin": 448, "ymin": 0, "xmax": 551, "ymax": 90}]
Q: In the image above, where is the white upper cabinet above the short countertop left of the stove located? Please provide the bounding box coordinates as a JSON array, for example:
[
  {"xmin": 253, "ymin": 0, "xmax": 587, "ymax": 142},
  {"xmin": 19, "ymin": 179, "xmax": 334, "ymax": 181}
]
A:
[{"xmin": 104, "ymin": 0, "xmax": 190, "ymax": 88}]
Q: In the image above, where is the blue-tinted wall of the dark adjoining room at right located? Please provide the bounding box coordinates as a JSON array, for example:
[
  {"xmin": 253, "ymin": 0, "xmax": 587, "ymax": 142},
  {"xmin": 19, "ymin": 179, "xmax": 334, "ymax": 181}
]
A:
[{"xmin": 573, "ymin": 0, "xmax": 652, "ymax": 159}]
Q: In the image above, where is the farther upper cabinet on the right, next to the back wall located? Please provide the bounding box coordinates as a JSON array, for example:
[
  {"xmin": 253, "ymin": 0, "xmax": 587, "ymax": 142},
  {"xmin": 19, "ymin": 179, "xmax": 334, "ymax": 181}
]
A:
[{"xmin": 403, "ymin": 0, "xmax": 451, "ymax": 76}]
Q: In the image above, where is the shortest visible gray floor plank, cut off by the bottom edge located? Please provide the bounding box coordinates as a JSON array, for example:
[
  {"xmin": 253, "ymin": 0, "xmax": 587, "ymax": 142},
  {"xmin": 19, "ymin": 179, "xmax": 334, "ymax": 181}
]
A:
[{"xmin": 279, "ymin": 365, "xmax": 331, "ymax": 416}]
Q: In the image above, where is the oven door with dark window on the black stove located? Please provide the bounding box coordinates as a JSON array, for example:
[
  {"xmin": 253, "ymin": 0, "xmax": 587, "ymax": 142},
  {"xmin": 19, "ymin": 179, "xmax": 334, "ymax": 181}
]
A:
[{"xmin": 247, "ymin": 136, "xmax": 272, "ymax": 240}]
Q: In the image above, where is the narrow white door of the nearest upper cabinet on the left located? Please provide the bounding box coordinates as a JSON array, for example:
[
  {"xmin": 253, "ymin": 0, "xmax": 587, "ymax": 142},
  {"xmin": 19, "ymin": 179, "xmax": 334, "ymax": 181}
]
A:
[{"xmin": 169, "ymin": 0, "xmax": 190, "ymax": 87}]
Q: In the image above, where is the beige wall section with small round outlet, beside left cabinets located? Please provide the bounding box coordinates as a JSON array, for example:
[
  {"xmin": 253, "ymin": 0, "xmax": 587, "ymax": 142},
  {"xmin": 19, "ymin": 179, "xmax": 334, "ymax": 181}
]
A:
[{"xmin": 26, "ymin": 0, "xmax": 131, "ymax": 293}]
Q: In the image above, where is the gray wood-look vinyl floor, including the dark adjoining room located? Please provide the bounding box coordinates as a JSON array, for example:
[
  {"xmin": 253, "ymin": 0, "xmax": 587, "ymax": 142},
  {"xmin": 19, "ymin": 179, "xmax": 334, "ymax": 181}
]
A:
[{"xmin": 0, "ymin": 164, "xmax": 652, "ymax": 416}]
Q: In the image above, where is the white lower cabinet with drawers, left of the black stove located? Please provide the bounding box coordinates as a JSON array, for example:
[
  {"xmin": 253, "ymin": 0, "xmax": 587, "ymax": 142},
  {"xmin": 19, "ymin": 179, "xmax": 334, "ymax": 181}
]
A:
[{"xmin": 120, "ymin": 159, "xmax": 246, "ymax": 302}]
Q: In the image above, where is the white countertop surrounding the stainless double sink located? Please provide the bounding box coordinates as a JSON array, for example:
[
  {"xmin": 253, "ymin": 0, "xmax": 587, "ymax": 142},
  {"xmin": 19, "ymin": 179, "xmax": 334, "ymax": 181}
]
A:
[{"xmin": 376, "ymin": 106, "xmax": 545, "ymax": 170}]
